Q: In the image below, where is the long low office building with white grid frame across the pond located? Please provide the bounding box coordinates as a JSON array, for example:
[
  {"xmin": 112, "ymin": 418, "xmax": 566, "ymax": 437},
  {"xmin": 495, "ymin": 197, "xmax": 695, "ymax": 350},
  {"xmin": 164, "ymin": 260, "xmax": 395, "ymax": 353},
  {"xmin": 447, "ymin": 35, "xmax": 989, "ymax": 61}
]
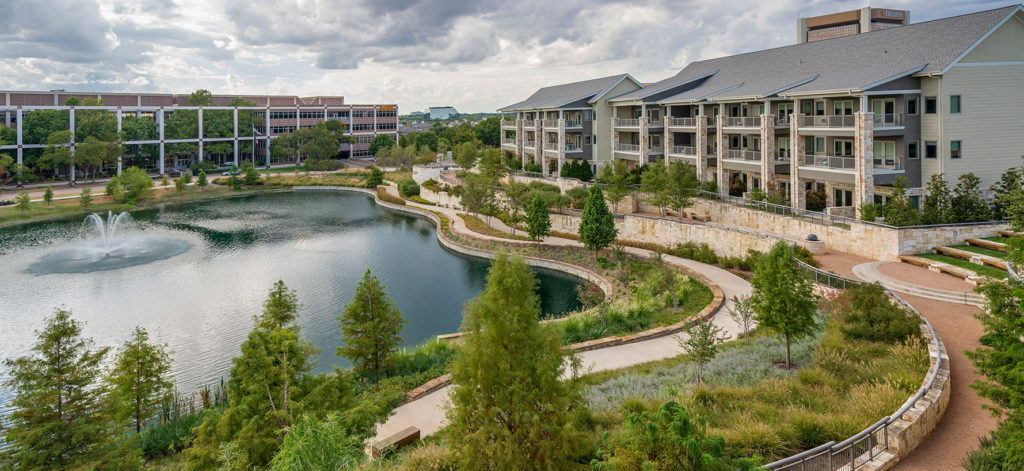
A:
[{"xmin": 0, "ymin": 90, "xmax": 398, "ymax": 173}]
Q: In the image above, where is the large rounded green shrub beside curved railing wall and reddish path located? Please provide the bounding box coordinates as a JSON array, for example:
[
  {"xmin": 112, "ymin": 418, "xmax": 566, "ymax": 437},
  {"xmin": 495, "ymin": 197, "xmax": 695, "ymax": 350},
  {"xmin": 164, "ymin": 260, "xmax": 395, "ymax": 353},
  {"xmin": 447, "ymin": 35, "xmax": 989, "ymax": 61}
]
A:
[{"xmin": 840, "ymin": 284, "xmax": 921, "ymax": 343}]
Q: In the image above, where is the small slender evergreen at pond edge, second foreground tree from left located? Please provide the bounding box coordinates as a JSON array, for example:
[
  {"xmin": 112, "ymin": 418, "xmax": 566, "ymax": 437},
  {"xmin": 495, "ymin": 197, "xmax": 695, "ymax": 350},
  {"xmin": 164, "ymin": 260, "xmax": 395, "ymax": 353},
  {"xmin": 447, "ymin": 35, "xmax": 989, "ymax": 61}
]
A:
[{"xmin": 108, "ymin": 327, "xmax": 174, "ymax": 433}]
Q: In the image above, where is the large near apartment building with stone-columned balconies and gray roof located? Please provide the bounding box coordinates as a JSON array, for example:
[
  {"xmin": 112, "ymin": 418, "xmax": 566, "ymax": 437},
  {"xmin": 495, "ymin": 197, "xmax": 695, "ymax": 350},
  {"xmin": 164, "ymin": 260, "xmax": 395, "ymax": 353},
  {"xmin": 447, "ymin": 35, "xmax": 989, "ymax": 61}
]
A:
[{"xmin": 505, "ymin": 5, "xmax": 1024, "ymax": 213}]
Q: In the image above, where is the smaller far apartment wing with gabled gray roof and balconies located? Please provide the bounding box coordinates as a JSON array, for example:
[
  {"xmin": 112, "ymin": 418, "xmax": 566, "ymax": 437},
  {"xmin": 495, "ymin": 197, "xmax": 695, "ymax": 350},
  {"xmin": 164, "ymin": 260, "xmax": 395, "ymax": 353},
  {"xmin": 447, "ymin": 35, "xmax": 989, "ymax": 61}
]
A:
[{"xmin": 499, "ymin": 74, "xmax": 643, "ymax": 174}]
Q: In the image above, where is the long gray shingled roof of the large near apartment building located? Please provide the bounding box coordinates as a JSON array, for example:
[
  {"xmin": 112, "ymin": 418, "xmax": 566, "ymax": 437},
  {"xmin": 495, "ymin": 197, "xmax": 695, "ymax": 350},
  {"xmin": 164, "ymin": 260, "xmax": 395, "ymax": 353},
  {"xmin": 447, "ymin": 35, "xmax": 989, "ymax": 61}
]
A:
[{"xmin": 612, "ymin": 5, "xmax": 1020, "ymax": 102}]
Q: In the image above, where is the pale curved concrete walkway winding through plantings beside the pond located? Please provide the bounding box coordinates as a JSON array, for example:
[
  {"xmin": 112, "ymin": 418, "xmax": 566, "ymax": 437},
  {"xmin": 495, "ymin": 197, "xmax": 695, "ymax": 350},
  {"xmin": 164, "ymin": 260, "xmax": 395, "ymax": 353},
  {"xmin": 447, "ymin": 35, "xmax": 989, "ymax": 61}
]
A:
[{"xmin": 374, "ymin": 228, "xmax": 751, "ymax": 442}]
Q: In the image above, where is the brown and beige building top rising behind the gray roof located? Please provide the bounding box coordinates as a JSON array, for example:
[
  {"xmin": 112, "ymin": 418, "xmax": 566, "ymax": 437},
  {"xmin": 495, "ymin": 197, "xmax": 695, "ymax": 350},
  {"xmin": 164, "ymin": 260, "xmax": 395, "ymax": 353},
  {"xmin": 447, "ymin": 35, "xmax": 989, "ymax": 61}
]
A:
[{"xmin": 797, "ymin": 6, "xmax": 910, "ymax": 43}]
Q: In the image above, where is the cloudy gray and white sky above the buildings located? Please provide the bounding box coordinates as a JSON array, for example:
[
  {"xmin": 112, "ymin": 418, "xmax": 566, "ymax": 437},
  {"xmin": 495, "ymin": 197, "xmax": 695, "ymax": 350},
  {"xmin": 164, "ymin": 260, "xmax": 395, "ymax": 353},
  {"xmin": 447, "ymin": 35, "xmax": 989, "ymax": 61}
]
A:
[{"xmin": 0, "ymin": 0, "xmax": 1013, "ymax": 113}]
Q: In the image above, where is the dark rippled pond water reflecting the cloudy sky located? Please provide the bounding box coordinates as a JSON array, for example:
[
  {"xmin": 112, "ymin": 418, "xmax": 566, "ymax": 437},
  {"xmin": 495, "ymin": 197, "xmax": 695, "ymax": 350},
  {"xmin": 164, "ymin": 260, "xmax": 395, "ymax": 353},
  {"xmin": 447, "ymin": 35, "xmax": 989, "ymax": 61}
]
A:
[{"xmin": 0, "ymin": 192, "xmax": 580, "ymax": 415}]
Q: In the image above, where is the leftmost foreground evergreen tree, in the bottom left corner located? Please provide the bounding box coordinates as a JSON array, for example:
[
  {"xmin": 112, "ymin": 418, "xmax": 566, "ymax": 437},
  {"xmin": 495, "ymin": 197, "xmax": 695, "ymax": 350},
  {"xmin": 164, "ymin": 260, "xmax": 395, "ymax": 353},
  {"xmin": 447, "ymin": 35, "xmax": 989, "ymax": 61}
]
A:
[{"xmin": 0, "ymin": 309, "xmax": 112, "ymax": 469}]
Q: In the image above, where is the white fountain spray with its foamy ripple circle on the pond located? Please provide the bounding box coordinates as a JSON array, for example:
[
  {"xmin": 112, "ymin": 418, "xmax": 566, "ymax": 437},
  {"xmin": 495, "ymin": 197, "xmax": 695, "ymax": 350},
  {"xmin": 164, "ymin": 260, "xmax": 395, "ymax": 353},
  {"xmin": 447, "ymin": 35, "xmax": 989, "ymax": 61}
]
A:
[{"xmin": 29, "ymin": 211, "xmax": 191, "ymax": 274}]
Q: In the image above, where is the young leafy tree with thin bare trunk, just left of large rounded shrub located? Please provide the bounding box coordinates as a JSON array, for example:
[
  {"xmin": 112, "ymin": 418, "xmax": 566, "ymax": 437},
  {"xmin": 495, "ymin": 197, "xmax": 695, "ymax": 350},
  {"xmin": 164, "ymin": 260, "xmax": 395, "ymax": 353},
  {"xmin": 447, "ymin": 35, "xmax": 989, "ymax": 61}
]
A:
[{"xmin": 750, "ymin": 242, "xmax": 817, "ymax": 369}]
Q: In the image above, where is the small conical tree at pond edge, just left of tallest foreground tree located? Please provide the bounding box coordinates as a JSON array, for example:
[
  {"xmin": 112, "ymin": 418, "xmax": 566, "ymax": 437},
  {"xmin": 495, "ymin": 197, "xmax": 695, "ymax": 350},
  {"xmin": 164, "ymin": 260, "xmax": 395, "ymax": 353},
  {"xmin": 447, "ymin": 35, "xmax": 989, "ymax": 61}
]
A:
[{"xmin": 338, "ymin": 269, "xmax": 406, "ymax": 376}]
